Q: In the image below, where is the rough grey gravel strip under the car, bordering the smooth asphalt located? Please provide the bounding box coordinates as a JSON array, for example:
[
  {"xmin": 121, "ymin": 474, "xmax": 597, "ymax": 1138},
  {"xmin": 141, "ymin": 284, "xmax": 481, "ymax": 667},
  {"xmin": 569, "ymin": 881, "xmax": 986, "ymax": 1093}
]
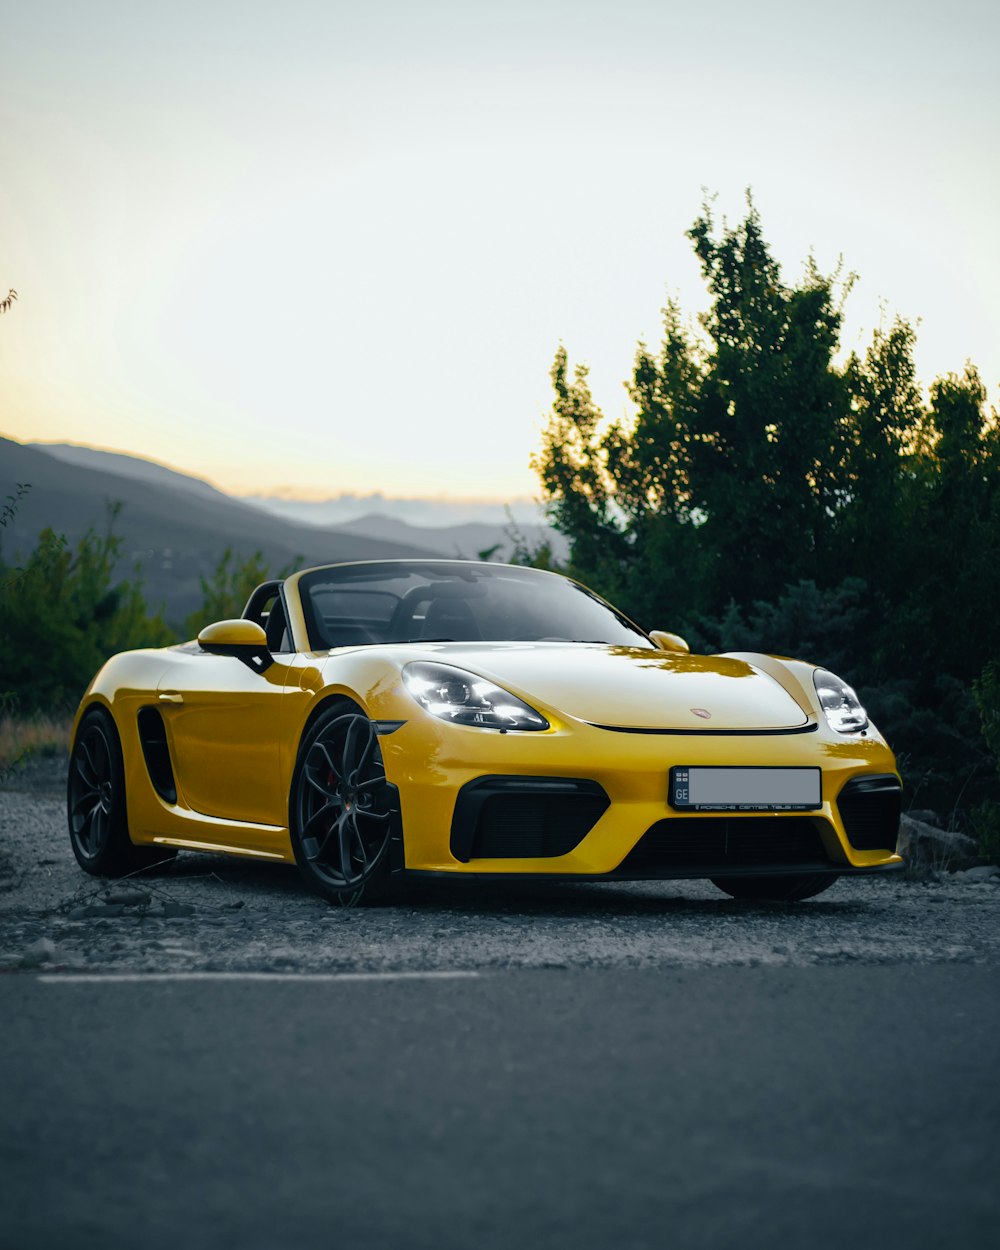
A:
[{"xmin": 0, "ymin": 760, "xmax": 1000, "ymax": 973}]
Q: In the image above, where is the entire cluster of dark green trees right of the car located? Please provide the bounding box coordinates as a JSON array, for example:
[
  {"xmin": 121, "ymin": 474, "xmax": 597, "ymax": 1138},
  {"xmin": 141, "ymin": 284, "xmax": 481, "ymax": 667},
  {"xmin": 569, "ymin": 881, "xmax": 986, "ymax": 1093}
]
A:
[{"xmin": 533, "ymin": 203, "xmax": 1000, "ymax": 810}]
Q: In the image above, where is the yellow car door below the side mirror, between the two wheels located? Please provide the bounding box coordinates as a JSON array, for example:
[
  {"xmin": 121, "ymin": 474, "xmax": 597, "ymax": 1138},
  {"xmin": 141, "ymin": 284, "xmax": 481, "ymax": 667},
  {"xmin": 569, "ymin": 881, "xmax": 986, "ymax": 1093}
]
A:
[{"xmin": 156, "ymin": 649, "xmax": 298, "ymax": 836}]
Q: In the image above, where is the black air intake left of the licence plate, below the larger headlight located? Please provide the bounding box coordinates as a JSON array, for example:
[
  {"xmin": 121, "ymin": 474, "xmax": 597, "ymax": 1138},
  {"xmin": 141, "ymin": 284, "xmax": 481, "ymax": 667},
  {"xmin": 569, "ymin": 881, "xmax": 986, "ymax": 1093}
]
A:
[{"xmin": 451, "ymin": 776, "xmax": 609, "ymax": 864}]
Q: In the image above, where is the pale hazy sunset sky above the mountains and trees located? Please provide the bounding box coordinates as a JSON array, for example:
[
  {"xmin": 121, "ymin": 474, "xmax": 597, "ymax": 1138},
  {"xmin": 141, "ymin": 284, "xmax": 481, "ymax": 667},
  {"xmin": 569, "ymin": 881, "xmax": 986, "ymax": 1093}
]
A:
[{"xmin": 0, "ymin": 0, "xmax": 1000, "ymax": 498}]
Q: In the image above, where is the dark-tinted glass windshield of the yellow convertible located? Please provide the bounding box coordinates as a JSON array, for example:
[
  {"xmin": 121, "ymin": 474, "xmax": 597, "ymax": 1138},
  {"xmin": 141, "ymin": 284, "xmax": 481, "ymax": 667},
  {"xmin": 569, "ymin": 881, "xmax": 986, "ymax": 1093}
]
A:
[{"xmin": 299, "ymin": 560, "xmax": 653, "ymax": 651}]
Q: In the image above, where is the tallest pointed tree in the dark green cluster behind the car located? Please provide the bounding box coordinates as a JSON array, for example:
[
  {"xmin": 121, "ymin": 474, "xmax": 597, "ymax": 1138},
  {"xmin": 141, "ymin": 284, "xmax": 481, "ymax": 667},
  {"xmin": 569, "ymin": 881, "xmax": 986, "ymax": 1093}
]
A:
[{"xmin": 689, "ymin": 204, "xmax": 846, "ymax": 603}]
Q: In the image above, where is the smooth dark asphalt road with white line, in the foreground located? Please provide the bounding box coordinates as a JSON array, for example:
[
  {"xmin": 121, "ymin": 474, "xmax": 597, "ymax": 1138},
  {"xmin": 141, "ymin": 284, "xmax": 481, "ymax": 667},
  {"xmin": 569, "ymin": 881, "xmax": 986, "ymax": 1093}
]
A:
[{"xmin": 0, "ymin": 964, "xmax": 1000, "ymax": 1250}]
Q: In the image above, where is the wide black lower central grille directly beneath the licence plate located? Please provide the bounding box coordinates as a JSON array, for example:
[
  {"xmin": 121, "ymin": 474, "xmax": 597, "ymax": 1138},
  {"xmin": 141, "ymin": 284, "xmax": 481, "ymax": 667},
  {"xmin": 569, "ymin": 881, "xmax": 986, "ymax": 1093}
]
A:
[{"xmin": 616, "ymin": 816, "xmax": 830, "ymax": 876}]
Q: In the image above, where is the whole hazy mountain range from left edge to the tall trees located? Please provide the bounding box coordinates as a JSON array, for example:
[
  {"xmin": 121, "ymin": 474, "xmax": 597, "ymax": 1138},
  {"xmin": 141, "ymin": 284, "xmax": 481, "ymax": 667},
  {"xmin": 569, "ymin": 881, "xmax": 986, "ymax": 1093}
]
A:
[{"xmin": 0, "ymin": 438, "xmax": 566, "ymax": 624}]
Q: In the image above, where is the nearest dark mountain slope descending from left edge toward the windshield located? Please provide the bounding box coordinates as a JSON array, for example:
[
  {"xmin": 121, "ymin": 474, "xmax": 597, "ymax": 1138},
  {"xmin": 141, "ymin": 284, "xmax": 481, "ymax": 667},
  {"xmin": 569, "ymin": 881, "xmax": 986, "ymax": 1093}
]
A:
[{"xmin": 0, "ymin": 438, "xmax": 439, "ymax": 624}]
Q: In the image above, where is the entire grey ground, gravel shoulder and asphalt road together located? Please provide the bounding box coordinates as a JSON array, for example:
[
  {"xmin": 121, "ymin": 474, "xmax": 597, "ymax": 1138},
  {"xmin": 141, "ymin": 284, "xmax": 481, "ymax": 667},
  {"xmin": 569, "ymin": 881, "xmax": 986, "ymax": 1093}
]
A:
[{"xmin": 0, "ymin": 769, "xmax": 1000, "ymax": 1250}]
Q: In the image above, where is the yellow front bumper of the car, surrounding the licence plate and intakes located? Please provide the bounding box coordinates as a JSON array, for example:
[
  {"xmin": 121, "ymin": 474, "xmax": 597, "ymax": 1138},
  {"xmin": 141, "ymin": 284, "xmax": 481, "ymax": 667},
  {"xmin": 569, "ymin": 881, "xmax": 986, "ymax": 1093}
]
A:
[{"xmin": 381, "ymin": 718, "xmax": 903, "ymax": 880}]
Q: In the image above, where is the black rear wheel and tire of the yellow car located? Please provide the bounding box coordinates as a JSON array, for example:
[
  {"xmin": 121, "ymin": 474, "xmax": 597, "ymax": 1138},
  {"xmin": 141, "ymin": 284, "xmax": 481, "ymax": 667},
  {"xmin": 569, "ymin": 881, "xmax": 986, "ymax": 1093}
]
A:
[{"xmin": 66, "ymin": 708, "xmax": 178, "ymax": 876}]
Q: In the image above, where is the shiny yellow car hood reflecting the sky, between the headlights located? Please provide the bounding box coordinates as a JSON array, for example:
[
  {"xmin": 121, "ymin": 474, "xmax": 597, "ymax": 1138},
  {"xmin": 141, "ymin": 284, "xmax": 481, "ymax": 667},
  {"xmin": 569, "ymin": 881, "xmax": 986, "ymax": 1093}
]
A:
[{"xmin": 415, "ymin": 643, "xmax": 809, "ymax": 731}]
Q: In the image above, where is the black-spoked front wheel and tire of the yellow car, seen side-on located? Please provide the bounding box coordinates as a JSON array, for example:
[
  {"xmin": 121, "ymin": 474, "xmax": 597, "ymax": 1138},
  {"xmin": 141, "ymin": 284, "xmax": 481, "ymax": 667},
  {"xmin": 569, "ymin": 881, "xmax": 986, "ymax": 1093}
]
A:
[{"xmin": 289, "ymin": 701, "xmax": 403, "ymax": 908}]
